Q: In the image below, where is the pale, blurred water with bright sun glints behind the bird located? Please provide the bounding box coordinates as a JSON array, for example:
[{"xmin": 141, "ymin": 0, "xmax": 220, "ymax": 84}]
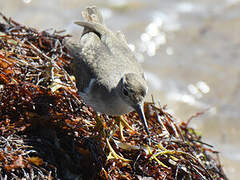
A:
[{"xmin": 0, "ymin": 0, "xmax": 240, "ymax": 179}]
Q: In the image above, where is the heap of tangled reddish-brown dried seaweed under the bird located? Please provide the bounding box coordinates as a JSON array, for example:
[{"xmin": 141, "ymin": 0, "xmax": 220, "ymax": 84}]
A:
[{"xmin": 0, "ymin": 14, "xmax": 227, "ymax": 179}]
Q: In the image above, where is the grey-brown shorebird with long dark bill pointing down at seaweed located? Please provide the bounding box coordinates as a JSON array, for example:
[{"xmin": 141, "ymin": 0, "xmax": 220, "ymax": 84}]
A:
[{"xmin": 68, "ymin": 6, "xmax": 150, "ymax": 135}]
